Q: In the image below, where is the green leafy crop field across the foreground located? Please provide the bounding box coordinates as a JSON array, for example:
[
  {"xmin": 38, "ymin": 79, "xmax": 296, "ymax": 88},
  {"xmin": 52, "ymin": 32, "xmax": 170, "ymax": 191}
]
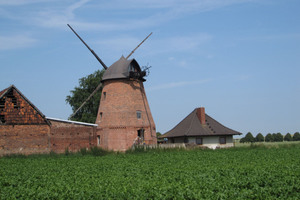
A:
[{"xmin": 0, "ymin": 145, "xmax": 300, "ymax": 199}]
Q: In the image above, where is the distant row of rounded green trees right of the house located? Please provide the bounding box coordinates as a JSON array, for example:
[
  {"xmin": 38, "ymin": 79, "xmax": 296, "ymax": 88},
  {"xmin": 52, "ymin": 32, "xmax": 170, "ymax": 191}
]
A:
[{"xmin": 240, "ymin": 132, "xmax": 300, "ymax": 143}]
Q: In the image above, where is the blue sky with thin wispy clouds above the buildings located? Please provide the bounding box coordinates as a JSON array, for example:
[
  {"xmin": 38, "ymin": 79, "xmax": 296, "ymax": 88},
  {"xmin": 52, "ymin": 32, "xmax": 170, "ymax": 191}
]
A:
[{"xmin": 0, "ymin": 0, "xmax": 300, "ymax": 138}]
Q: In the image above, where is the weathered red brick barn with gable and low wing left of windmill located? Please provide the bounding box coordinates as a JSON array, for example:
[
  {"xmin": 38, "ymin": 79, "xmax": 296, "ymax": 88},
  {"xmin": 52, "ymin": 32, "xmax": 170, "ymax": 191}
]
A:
[{"xmin": 0, "ymin": 85, "xmax": 97, "ymax": 155}]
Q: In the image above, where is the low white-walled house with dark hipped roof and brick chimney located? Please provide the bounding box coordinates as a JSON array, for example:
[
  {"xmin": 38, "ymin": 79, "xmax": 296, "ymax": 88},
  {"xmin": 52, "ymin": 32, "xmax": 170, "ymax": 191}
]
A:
[{"xmin": 160, "ymin": 107, "xmax": 242, "ymax": 149}]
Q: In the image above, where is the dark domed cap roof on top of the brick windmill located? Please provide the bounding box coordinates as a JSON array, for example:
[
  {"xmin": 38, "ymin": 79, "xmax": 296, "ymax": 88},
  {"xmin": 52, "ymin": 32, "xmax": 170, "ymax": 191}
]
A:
[{"xmin": 102, "ymin": 56, "xmax": 141, "ymax": 81}]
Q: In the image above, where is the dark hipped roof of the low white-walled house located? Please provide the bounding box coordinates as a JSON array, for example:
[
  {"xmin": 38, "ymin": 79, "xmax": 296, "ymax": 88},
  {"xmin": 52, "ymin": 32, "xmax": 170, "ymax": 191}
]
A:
[{"xmin": 160, "ymin": 109, "xmax": 242, "ymax": 138}]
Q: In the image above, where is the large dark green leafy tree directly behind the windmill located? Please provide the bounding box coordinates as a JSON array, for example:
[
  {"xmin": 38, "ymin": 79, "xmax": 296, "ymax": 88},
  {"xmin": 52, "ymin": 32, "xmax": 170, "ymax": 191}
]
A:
[{"xmin": 66, "ymin": 70, "xmax": 105, "ymax": 123}]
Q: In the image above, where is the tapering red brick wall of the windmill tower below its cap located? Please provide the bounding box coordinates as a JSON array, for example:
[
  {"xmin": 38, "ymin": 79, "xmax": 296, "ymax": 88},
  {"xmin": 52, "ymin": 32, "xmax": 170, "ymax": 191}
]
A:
[{"xmin": 96, "ymin": 79, "xmax": 157, "ymax": 151}]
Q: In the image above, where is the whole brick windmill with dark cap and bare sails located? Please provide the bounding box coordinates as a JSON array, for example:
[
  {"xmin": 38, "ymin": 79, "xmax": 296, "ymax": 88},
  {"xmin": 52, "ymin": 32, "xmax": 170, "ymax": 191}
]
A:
[{"xmin": 68, "ymin": 25, "xmax": 157, "ymax": 151}]
